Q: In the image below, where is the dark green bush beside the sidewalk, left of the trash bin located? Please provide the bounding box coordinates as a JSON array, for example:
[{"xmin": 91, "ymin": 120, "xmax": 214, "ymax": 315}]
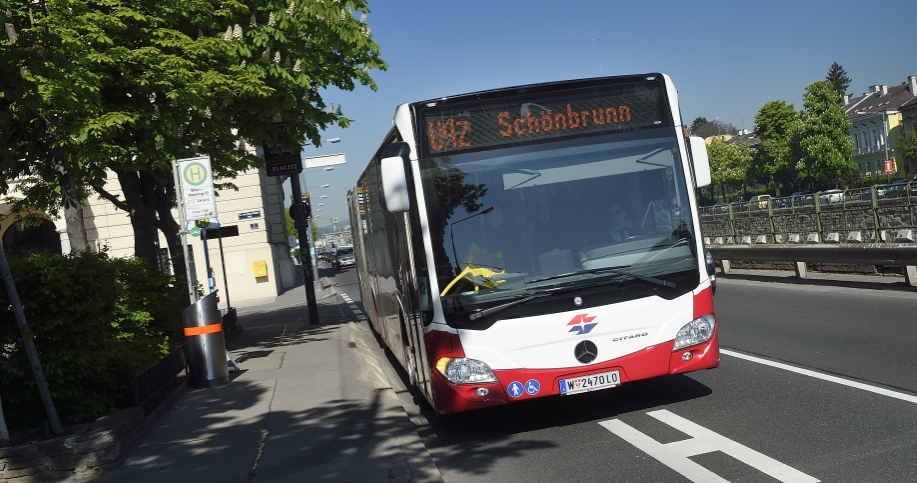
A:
[{"xmin": 0, "ymin": 252, "xmax": 184, "ymax": 431}]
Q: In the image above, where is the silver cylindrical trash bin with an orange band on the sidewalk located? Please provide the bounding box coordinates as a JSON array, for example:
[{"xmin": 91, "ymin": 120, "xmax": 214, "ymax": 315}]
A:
[{"xmin": 182, "ymin": 292, "xmax": 229, "ymax": 389}]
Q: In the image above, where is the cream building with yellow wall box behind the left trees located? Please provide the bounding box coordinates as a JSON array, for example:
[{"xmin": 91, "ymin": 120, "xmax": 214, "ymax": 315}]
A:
[{"xmin": 0, "ymin": 169, "xmax": 296, "ymax": 302}]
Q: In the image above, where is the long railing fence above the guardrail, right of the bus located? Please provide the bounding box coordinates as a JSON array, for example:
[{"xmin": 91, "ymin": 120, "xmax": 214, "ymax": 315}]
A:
[{"xmin": 700, "ymin": 181, "xmax": 917, "ymax": 245}]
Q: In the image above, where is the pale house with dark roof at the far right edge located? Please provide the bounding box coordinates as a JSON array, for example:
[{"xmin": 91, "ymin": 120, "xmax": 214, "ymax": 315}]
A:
[{"xmin": 842, "ymin": 75, "xmax": 917, "ymax": 178}]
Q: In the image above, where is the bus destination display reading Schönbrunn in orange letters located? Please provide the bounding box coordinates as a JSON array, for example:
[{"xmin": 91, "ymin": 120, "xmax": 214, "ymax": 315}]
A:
[{"xmin": 423, "ymin": 82, "xmax": 670, "ymax": 155}]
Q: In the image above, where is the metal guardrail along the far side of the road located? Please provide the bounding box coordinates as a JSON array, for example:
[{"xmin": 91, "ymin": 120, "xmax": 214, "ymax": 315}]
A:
[{"xmin": 707, "ymin": 244, "xmax": 917, "ymax": 287}]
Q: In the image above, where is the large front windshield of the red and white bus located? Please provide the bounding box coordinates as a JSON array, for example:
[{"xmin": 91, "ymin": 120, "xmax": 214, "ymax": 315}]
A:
[{"xmin": 421, "ymin": 128, "xmax": 698, "ymax": 322}]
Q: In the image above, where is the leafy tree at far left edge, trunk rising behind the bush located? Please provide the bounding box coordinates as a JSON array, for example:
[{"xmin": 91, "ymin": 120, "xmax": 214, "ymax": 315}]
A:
[{"xmin": 0, "ymin": 1, "xmax": 98, "ymax": 251}]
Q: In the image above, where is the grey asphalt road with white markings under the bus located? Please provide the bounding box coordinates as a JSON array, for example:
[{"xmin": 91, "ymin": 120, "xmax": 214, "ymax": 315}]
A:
[{"xmin": 325, "ymin": 264, "xmax": 917, "ymax": 482}]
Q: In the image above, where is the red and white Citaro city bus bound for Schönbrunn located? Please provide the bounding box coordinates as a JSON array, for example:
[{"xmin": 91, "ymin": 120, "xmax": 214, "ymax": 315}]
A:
[{"xmin": 348, "ymin": 73, "xmax": 719, "ymax": 414}]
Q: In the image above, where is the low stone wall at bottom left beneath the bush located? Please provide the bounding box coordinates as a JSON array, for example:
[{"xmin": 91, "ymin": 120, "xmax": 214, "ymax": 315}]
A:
[{"xmin": 0, "ymin": 408, "xmax": 144, "ymax": 483}]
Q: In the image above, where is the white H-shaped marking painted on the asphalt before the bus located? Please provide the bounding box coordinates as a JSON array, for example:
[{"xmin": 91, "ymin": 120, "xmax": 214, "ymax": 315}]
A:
[{"xmin": 599, "ymin": 409, "xmax": 820, "ymax": 483}]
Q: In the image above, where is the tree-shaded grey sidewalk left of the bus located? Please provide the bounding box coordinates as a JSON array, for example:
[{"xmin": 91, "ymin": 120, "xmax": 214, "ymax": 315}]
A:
[{"xmin": 85, "ymin": 286, "xmax": 442, "ymax": 483}]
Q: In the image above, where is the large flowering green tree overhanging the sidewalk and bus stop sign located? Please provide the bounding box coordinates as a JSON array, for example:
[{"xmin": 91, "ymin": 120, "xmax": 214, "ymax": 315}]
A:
[{"xmin": 0, "ymin": 0, "xmax": 386, "ymax": 274}]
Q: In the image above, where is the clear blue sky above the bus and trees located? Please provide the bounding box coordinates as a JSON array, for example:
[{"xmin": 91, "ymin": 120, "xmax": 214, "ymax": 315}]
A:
[{"xmin": 292, "ymin": 0, "xmax": 917, "ymax": 228}]
